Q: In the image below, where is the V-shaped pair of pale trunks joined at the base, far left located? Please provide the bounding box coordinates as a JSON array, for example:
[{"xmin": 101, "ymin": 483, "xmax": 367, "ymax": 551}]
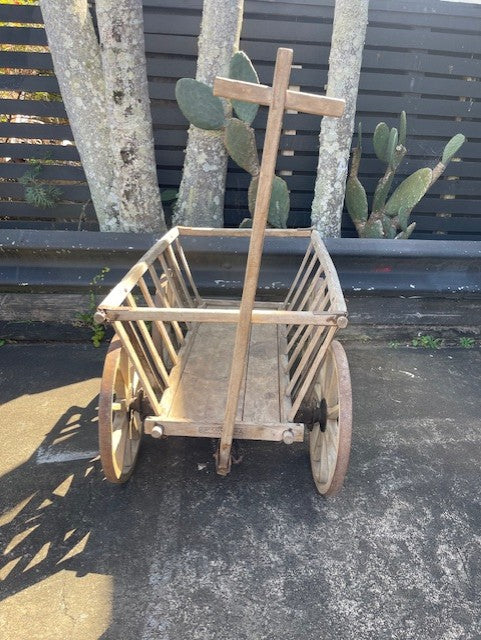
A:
[{"xmin": 40, "ymin": 0, "xmax": 165, "ymax": 232}]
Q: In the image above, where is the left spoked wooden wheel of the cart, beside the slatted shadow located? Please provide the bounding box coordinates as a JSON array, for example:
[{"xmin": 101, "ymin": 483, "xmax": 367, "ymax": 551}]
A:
[{"xmin": 99, "ymin": 336, "xmax": 143, "ymax": 483}]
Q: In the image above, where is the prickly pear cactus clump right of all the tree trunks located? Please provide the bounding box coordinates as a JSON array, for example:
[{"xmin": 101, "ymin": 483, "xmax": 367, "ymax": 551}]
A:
[{"xmin": 346, "ymin": 111, "xmax": 466, "ymax": 240}]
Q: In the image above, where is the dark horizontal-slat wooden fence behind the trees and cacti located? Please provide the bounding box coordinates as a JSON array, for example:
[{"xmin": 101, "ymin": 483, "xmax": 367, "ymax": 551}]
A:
[{"xmin": 0, "ymin": 0, "xmax": 481, "ymax": 240}]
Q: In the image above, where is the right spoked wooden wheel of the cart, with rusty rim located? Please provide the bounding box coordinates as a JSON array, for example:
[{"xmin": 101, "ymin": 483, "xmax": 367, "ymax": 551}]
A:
[{"xmin": 309, "ymin": 340, "xmax": 352, "ymax": 496}]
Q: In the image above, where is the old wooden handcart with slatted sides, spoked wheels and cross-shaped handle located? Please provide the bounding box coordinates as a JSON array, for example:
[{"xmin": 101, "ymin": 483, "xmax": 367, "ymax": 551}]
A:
[{"xmin": 96, "ymin": 49, "xmax": 351, "ymax": 495}]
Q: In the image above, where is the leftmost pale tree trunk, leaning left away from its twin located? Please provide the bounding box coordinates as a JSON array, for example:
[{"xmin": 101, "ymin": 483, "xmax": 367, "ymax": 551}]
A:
[{"xmin": 40, "ymin": 0, "xmax": 122, "ymax": 231}]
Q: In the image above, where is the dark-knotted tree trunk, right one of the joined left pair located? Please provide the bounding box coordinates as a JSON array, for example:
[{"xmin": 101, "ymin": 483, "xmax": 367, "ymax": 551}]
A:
[{"xmin": 95, "ymin": 0, "xmax": 166, "ymax": 233}]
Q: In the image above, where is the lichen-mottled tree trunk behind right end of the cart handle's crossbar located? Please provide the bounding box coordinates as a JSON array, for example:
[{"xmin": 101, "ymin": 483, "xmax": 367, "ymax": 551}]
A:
[{"xmin": 312, "ymin": 0, "xmax": 369, "ymax": 237}]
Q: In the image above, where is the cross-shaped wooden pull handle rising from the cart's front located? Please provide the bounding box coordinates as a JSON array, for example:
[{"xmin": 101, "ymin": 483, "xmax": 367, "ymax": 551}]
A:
[{"xmin": 214, "ymin": 48, "xmax": 344, "ymax": 475}]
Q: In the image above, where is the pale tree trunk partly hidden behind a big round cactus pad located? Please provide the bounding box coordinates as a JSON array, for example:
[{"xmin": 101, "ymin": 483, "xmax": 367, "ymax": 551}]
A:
[{"xmin": 174, "ymin": 0, "xmax": 244, "ymax": 227}]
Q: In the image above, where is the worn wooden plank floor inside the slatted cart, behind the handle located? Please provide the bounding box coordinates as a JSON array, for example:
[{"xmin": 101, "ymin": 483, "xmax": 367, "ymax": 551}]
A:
[{"xmin": 159, "ymin": 323, "xmax": 281, "ymax": 424}]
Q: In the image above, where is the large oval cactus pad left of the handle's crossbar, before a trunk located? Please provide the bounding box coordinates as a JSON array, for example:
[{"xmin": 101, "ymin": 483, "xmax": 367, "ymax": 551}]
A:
[{"xmin": 175, "ymin": 78, "xmax": 225, "ymax": 130}]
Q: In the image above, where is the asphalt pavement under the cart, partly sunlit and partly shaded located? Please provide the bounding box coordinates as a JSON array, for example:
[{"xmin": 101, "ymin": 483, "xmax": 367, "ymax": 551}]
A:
[{"xmin": 0, "ymin": 344, "xmax": 481, "ymax": 640}]
